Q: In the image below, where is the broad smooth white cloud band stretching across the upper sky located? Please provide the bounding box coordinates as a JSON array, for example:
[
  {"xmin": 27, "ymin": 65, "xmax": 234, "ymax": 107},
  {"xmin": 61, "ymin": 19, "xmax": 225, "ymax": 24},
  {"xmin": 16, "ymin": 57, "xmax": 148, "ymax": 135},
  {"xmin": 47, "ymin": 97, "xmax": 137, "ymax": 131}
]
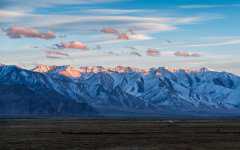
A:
[{"xmin": 1, "ymin": 9, "xmax": 219, "ymax": 41}]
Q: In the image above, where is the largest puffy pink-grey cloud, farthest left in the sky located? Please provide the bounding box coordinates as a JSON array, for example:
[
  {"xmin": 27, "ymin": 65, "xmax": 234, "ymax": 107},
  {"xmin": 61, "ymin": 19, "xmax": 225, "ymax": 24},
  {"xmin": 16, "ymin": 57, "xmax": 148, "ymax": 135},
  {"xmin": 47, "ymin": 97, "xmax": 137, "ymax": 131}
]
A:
[{"xmin": 5, "ymin": 26, "xmax": 56, "ymax": 40}]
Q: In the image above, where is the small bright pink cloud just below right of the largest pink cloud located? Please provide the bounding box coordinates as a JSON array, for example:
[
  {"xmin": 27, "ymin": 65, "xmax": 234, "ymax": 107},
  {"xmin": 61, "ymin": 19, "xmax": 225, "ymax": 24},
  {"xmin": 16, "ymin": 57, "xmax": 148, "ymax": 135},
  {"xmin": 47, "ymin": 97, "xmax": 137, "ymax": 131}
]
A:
[{"xmin": 56, "ymin": 41, "xmax": 88, "ymax": 50}]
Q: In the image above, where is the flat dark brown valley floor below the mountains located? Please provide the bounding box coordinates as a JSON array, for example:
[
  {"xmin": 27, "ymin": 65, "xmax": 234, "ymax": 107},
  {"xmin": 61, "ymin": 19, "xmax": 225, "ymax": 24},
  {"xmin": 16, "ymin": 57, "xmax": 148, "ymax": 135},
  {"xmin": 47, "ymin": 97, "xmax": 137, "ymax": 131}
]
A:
[{"xmin": 0, "ymin": 119, "xmax": 240, "ymax": 150}]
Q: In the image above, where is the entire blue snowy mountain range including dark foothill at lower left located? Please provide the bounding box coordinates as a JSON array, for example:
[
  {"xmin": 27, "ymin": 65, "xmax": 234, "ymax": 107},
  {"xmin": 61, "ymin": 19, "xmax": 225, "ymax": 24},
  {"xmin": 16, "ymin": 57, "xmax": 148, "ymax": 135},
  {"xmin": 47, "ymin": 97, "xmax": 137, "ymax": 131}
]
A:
[{"xmin": 0, "ymin": 65, "xmax": 240, "ymax": 116}]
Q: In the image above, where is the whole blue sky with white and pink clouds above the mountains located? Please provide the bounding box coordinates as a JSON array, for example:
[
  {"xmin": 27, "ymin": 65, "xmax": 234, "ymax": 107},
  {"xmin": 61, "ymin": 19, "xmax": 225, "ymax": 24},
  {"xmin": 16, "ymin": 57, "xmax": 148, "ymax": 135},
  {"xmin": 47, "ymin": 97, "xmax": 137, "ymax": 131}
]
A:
[{"xmin": 0, "ymin": 0, "xmax": 240, "ymax": 74}]
